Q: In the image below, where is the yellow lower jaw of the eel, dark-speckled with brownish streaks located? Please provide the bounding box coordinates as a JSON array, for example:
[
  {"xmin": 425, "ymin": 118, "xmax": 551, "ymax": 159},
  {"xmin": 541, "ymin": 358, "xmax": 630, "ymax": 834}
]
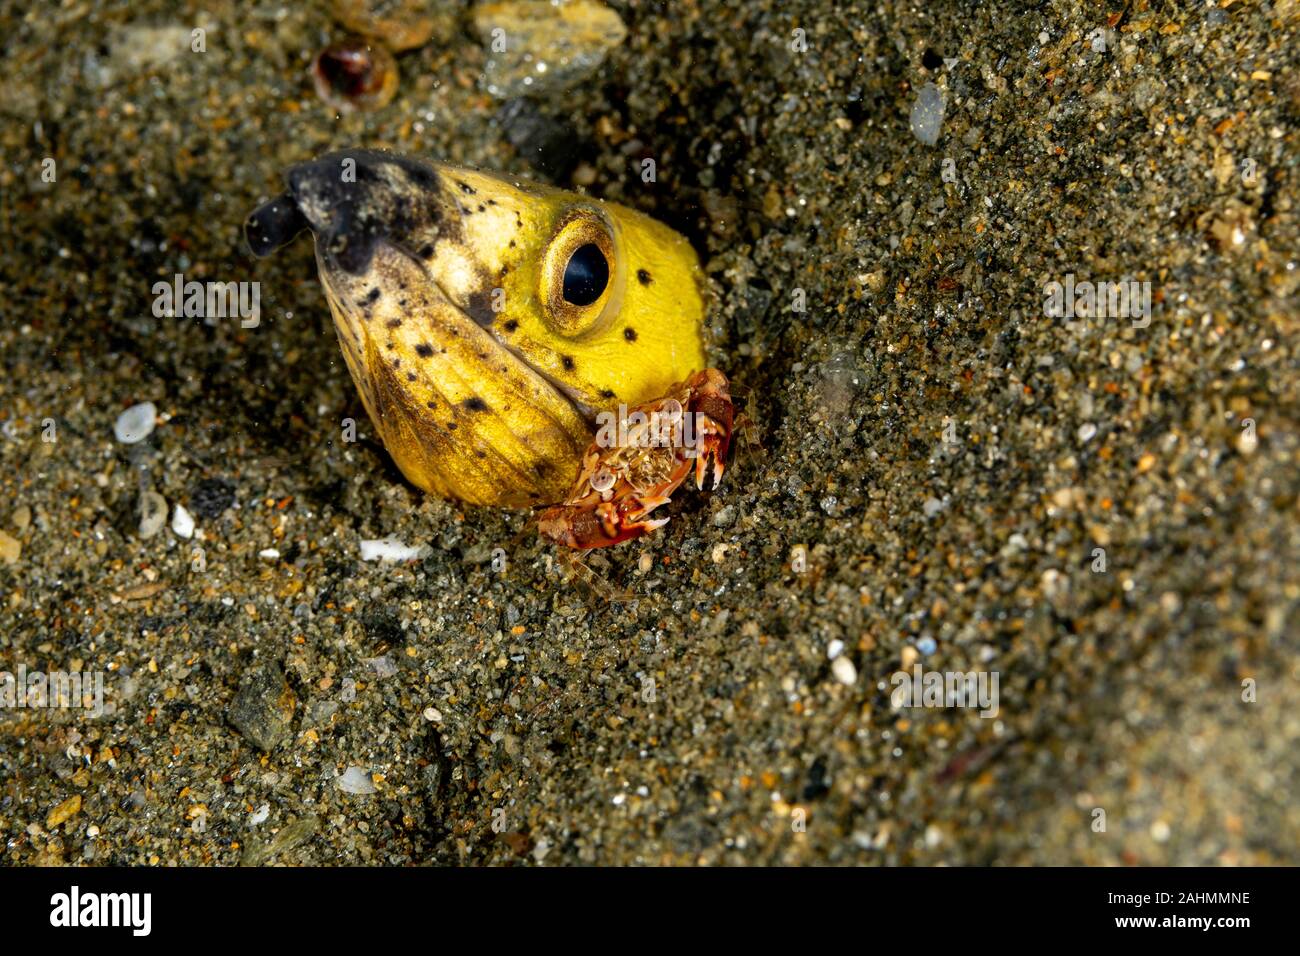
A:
[{"xmin": 317, "ymin": 235, "xmax": 592, "ymax": 507}]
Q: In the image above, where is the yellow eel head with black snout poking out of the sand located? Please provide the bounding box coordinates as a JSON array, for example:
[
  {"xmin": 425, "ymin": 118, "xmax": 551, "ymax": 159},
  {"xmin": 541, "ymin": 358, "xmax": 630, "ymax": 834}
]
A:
[{"xmin": 244, "ymin": 150, "xmax": 705, "ymax": 507}]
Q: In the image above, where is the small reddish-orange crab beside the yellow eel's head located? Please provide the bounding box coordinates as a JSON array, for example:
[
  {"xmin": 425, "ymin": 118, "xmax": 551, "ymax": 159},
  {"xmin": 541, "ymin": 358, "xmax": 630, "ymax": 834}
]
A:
[{"xmin": 537, "ymin": 368, "xmax": 736, "ymax": 551}]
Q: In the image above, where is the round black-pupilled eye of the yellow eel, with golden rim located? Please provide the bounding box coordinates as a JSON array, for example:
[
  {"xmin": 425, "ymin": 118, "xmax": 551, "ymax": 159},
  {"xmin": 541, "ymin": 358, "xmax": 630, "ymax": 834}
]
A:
[{"xmin": 540, "ymin": 207, "xmax": 621, "ymax": 337}]
